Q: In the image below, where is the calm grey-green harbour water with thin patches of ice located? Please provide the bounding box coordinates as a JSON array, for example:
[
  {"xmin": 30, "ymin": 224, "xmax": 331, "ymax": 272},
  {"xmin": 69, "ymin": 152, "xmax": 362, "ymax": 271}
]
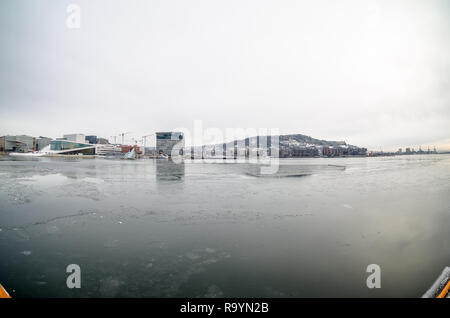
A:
[{"xmin": 0, "ymin": 155, "xmax": 450, "ymax": 297}]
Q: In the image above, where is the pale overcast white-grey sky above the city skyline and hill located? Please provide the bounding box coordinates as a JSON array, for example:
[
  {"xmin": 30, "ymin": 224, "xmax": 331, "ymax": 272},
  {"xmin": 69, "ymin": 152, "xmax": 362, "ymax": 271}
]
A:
[{"xmin": 0, "ymin": 0, "xmax": 450, "ymax": 150}]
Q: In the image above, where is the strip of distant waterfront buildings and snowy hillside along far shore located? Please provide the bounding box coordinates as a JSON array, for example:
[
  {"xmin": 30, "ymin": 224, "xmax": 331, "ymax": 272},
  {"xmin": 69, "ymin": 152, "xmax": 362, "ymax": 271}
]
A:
[{"xmin": 0, "ymin": 132, "xmax": 438, "ymax": 159}]
